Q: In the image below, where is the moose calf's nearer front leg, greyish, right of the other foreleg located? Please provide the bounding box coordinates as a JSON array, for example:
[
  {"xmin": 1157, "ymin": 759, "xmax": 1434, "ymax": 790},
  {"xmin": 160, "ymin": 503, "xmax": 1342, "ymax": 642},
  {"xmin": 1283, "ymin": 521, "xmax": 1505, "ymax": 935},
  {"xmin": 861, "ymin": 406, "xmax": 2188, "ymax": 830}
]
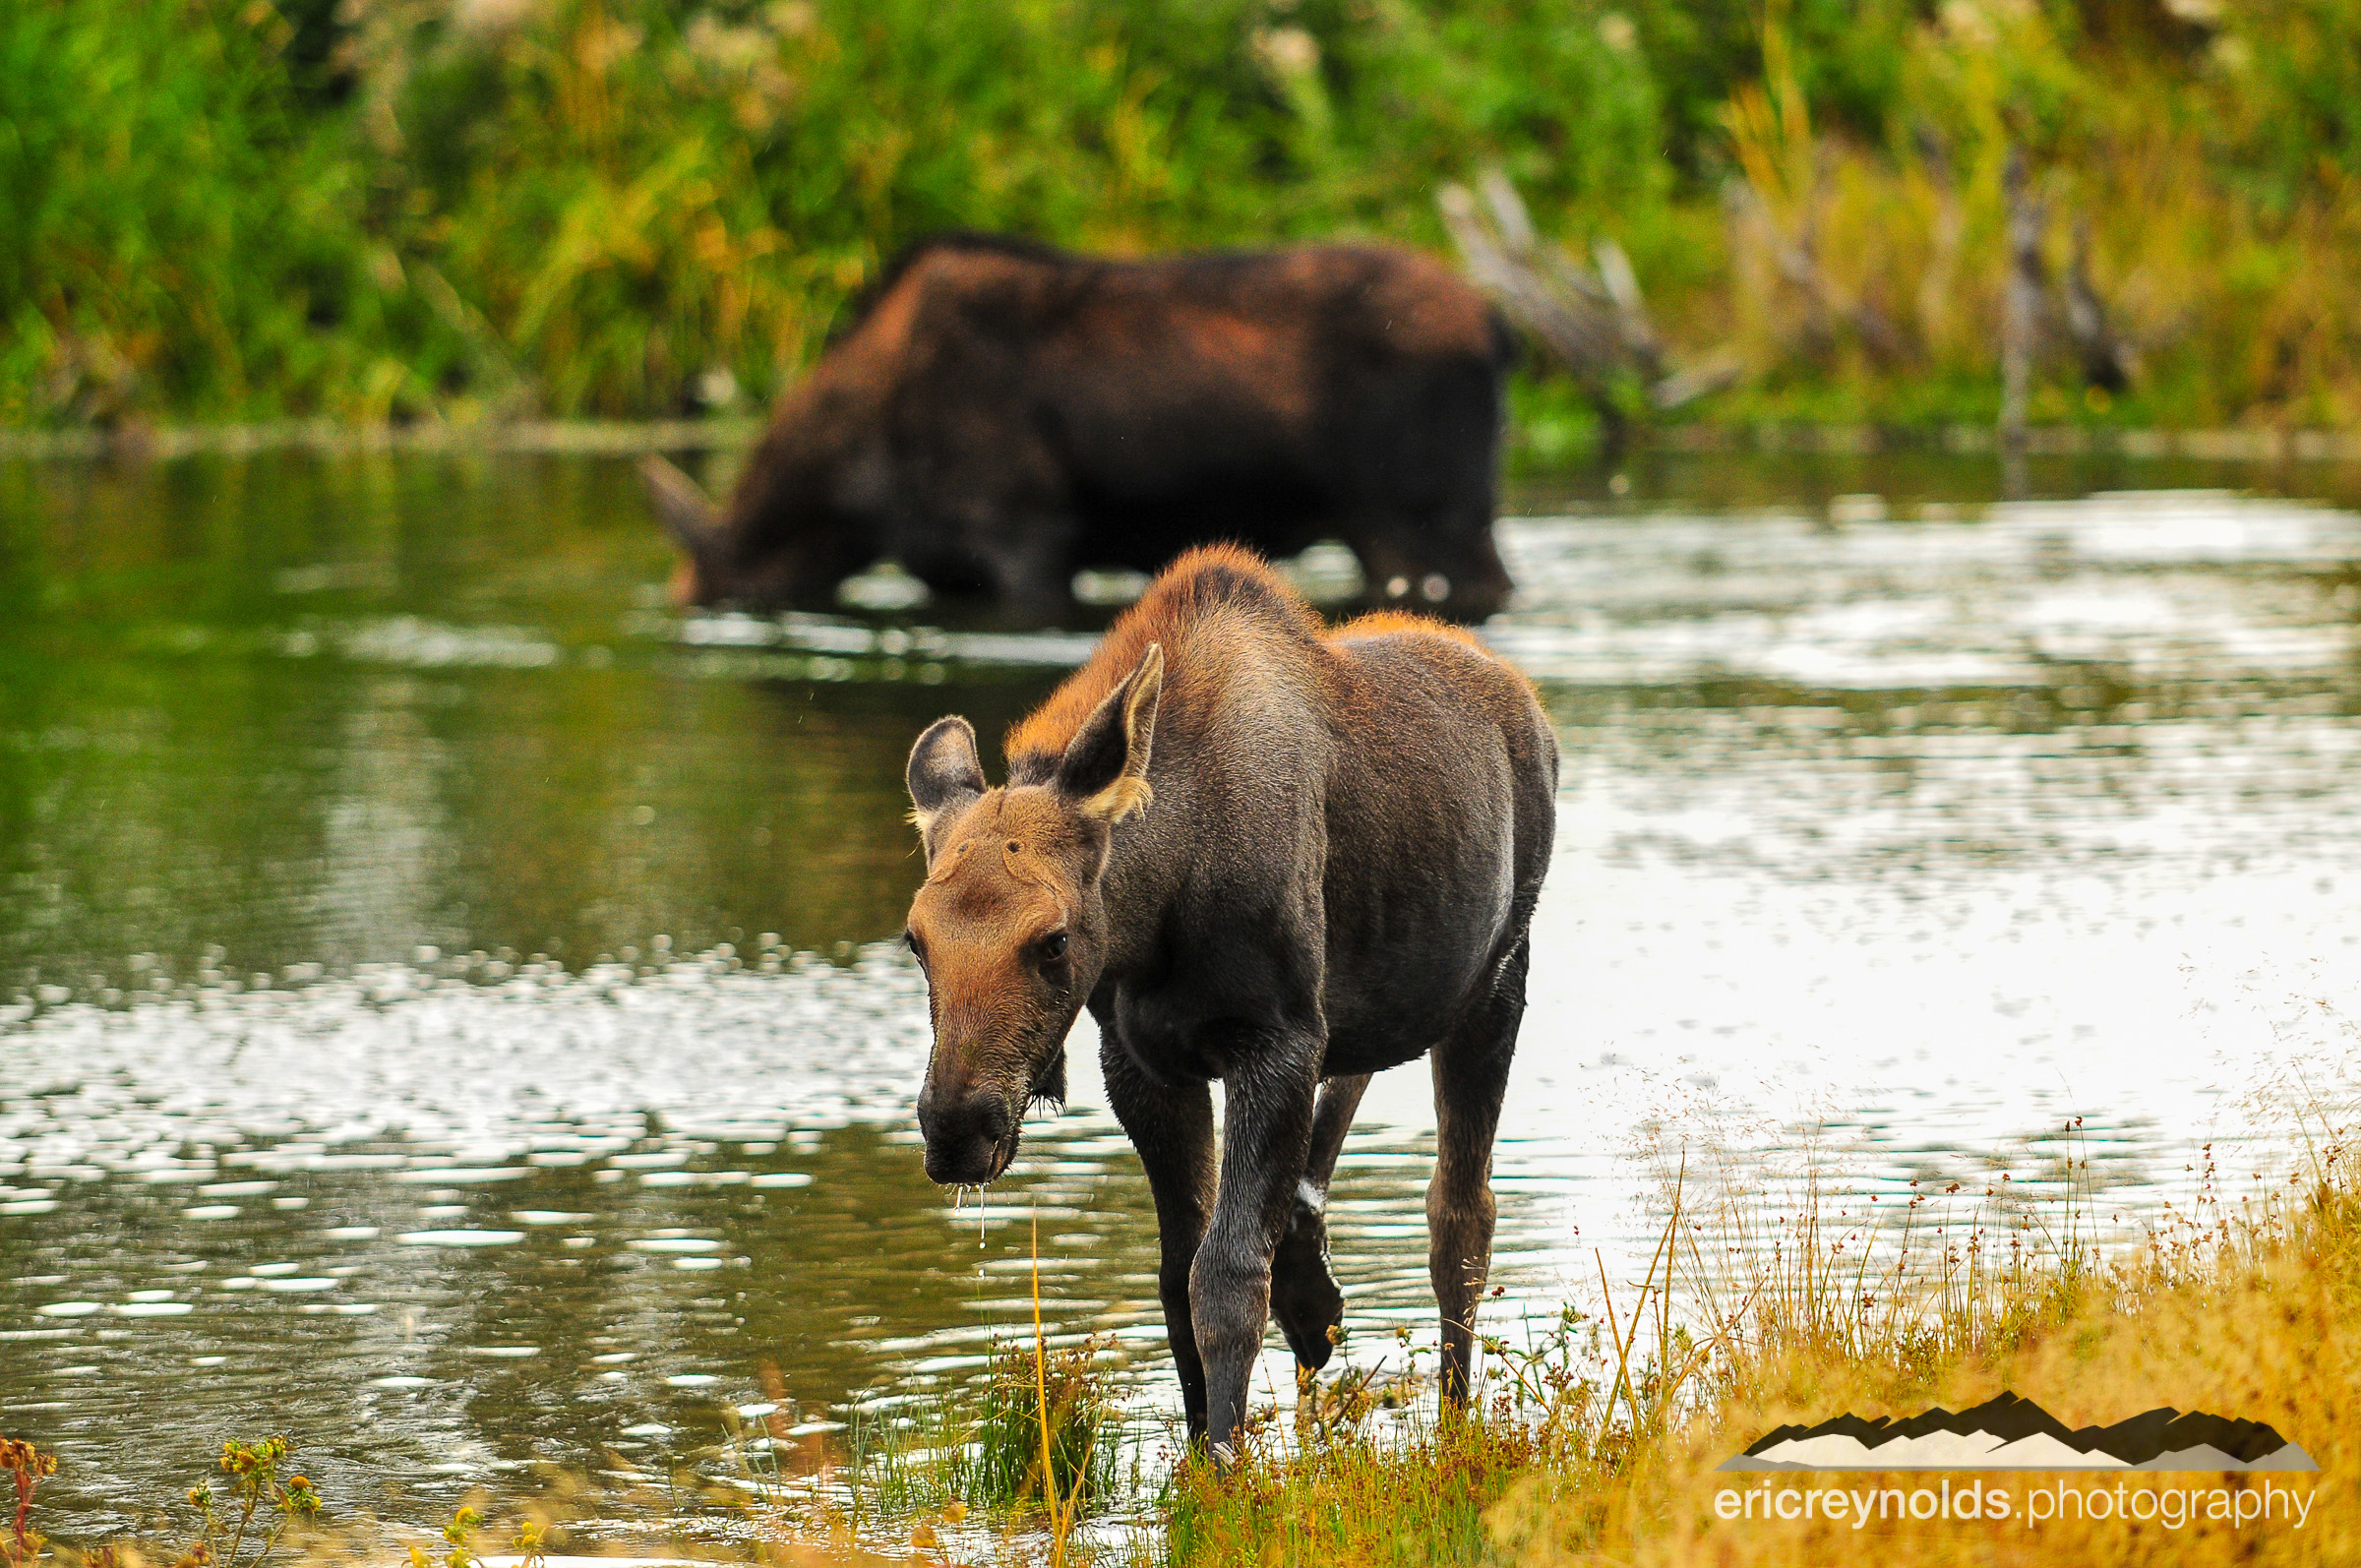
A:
[{"xmin": 1187, "ymin": 1039, "xmax": 1322, "ymax": 1464}]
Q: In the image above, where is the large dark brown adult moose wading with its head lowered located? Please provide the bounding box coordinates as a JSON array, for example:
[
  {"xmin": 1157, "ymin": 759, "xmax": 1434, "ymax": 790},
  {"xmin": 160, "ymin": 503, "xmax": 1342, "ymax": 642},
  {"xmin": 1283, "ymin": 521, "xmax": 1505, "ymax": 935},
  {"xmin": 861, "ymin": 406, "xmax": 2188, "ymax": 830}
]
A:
[{"xmin": 647, "ymin": 234, "xmax": 1509, "ymax": 619}]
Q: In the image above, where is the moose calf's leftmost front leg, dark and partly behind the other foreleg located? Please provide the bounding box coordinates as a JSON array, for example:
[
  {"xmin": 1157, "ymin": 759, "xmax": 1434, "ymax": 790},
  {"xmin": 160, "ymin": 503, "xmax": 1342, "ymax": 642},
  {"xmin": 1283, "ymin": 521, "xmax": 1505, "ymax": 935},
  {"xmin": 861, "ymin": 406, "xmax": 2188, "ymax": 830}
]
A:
[{"xmin": 1098, "ymin": 1034, "xmax": 1214, "ymax": 1438}]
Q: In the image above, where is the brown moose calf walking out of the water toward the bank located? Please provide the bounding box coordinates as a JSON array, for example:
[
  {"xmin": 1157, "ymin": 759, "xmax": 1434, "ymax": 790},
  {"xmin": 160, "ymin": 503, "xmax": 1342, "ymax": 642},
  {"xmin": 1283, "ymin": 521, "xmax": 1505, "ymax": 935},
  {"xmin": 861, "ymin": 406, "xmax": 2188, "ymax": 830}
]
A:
[{"xmin": 909, "ymin": 548, "xmax": 1558, "ymax": 1450}]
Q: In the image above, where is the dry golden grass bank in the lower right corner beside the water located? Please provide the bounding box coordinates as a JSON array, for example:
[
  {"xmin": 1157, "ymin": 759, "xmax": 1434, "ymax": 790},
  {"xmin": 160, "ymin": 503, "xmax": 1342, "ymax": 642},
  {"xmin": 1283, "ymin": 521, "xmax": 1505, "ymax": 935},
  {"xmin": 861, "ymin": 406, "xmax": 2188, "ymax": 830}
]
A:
[{"xmin": 1167, "ymin": 1091, "xmax": 2361, "ymax": 1568}]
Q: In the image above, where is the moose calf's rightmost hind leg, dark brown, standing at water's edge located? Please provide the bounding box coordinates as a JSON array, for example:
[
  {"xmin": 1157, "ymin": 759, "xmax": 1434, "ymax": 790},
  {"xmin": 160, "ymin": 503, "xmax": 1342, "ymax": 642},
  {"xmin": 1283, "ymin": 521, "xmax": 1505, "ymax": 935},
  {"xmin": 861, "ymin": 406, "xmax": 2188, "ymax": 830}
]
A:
[{"xmin": 1426, "ymin": 935, "xmax": 1530, "ymax": 1405}]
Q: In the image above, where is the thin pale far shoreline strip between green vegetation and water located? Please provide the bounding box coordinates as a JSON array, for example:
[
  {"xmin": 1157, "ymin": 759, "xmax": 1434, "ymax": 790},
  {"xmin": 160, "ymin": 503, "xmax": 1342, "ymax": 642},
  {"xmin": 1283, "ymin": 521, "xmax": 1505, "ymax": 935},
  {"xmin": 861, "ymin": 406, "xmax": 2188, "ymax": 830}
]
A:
[{"xmin": 14, "ymin": 416, "xmax": 2361, "ymax": 467}]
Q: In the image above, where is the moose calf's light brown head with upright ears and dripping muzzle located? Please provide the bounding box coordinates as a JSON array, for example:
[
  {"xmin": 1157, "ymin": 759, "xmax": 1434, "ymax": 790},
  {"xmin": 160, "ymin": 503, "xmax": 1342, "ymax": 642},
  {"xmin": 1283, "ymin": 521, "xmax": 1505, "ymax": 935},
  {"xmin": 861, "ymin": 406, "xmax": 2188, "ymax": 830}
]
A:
[{"xmin": 907, "ymin": 642, "xmax": 1164, "ymax": 1185}]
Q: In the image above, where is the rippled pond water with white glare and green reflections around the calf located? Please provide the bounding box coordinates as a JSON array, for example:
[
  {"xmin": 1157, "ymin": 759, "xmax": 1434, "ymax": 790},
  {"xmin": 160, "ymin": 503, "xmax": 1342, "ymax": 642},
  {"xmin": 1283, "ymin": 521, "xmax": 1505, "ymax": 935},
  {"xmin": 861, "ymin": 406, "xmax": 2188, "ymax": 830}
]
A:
[{"xmin": 0, "ymin": 455, "xmax": 2361, "ymax": 1531}]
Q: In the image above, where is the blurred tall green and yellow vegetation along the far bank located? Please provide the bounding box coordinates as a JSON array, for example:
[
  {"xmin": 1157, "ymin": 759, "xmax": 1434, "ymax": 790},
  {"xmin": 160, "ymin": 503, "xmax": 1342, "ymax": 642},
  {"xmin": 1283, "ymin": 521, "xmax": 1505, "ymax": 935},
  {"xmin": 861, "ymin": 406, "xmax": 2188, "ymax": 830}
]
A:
[{"xmin": 14, "ymin": 0, "xmax": 2361, "ymax": 425}]
